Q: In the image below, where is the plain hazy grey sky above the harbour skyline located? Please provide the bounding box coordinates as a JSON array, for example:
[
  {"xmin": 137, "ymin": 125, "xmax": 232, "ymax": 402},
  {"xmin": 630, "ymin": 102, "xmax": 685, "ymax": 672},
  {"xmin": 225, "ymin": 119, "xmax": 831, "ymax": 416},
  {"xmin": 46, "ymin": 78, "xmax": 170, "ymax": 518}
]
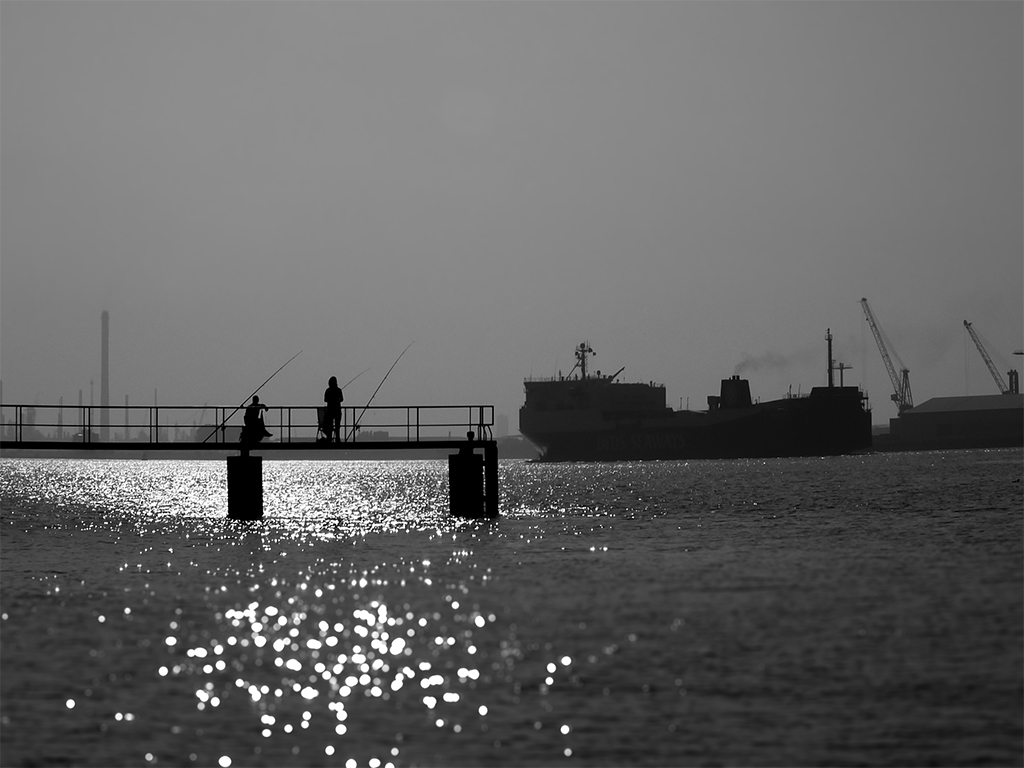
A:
[{"xmin": 0, "ymin": 0, "xmax": 1024, "ymax": 432}]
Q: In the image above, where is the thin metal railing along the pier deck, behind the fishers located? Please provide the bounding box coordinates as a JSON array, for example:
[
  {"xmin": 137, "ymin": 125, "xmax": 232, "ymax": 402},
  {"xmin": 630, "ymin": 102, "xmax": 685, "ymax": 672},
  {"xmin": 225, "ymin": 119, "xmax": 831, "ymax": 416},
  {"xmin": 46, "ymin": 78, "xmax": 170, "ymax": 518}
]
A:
[{"xmin": 0, "ymin": 403, "xmax": 495, "ymax": 447}]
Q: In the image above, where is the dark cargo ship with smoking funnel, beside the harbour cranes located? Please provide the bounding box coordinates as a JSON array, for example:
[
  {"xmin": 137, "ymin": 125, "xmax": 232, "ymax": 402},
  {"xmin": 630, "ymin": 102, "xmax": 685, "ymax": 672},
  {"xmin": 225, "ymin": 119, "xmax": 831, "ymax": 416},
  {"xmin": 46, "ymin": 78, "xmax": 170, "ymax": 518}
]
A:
[{"xmin": 519, "ymin": 332, "xmax": 871, "ymax": 462}]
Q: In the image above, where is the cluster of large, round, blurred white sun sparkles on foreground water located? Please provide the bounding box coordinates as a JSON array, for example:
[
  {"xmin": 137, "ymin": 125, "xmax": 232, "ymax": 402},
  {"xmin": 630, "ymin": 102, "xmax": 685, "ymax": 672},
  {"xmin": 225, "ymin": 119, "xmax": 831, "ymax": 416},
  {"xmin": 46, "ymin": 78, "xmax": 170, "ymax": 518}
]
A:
[{"xmin": 151, "ymin": 544, "xmax": 585, "ymax": 765}]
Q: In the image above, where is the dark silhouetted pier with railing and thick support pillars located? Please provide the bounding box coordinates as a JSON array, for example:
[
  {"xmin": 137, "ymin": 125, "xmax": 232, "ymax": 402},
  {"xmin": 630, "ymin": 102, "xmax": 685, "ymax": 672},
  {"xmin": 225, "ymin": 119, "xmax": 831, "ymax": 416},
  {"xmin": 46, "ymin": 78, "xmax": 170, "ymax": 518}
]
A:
[{"xmin": 0, "ymin": 403, "xmax": 498, "ymax": 520}]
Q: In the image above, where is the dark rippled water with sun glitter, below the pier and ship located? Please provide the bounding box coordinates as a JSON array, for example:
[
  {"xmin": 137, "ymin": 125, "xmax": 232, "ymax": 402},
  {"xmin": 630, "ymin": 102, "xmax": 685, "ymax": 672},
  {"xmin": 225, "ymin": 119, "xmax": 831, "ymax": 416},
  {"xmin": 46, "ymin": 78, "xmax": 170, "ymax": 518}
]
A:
[{"xmin": 0, "ymin": 451, "xmax": 1024, "ymax": 768}]
